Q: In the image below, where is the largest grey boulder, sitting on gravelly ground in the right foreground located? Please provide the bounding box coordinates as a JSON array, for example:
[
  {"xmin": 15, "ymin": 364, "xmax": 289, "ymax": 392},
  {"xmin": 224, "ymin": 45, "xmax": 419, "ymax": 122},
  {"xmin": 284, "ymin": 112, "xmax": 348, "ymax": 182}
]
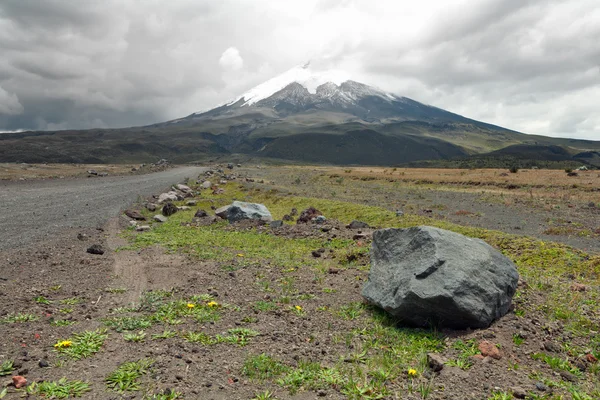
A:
[{"xmin": 362, "ymin": 226, "xmax": 519, "ymax": 329}]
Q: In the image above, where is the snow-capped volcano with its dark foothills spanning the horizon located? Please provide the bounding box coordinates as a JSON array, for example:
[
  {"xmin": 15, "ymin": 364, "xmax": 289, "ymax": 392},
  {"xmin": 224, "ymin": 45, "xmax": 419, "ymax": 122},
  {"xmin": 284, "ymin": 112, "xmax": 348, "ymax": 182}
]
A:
[{"xmin": 0, "ymin": 65, "xmax": 600, "ymax": 166}]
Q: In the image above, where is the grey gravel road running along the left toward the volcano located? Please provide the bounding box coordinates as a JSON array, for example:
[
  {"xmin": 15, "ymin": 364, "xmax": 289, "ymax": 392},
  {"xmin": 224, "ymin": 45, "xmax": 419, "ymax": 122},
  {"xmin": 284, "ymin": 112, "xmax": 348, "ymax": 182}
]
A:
[{"xmin": 0, "ymin": 167, "xmax": 205, "ymax": 251}]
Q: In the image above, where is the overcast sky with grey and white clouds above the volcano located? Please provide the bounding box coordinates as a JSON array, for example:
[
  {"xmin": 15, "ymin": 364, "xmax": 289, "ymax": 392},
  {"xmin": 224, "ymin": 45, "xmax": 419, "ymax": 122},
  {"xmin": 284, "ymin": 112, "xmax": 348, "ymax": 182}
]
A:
[{"xmin": 0, "ymin": 0, "xmax": 600, "ymax": 140}]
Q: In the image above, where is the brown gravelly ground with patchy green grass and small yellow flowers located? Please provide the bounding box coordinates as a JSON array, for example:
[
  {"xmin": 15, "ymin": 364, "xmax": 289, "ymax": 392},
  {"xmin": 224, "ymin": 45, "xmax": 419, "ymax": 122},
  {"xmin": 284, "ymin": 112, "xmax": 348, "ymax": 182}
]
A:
[{"xmin": 0, "ymin": 163, "xmax": 600, "ymax": 400}]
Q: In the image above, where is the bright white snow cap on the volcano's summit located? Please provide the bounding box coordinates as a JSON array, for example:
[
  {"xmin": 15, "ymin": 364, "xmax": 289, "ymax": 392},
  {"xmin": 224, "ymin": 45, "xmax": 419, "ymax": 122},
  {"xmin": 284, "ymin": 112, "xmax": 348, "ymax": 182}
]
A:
[{"xmin": 229, "ymin": 62, "xmax": 349, "ymax": 106}]
